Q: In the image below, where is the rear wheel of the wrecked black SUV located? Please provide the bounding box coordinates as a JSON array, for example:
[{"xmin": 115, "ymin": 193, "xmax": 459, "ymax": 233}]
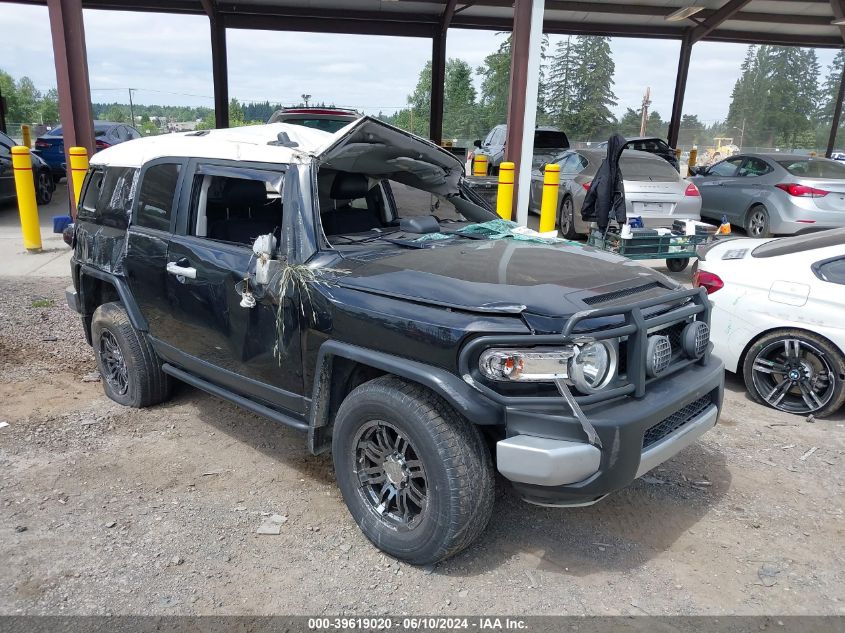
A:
[{"xmin": 91, "ymin": 303, "xmax": 171, "ymax": 408}]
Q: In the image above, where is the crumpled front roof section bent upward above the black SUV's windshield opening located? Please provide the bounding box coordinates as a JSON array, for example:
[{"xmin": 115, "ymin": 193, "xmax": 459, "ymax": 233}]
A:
[{"xmin": 314, "ymin": 116, "xmax": 464, "ymax": 196}]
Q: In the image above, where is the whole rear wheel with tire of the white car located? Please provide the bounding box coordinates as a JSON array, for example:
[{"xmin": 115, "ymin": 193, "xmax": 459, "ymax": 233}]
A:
[{"xmin": 743, "ymin": 330, "xmax": 845, "ymax": 417}]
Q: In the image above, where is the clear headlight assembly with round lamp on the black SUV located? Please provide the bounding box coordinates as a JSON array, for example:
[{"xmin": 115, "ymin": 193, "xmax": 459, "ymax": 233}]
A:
[{"xmin": 478, "ymin": 341, "xmax": 617, "ymax": 393}]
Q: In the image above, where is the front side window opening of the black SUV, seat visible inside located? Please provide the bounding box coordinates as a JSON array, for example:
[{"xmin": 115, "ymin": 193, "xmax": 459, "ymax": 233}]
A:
[{"xmin": 188, "ymin": 168, "xmax": 284, "ymax": 246}]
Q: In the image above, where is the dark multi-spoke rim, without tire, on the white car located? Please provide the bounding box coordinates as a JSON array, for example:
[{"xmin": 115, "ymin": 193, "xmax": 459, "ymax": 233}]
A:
[{"xmin": 752, "ymin": 338, "xmax": 837, "ymax": 414}]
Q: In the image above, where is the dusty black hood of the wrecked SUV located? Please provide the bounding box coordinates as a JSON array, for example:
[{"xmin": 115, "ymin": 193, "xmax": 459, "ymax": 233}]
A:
[{"xmin": 336, "ymin": 239, "xmax": 677, "ymax": 317}]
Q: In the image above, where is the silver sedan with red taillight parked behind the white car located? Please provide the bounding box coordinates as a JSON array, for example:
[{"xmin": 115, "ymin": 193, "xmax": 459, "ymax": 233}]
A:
[{"xmin": 690, "ymin": 154, "xmax": 845, "ymax": 237}]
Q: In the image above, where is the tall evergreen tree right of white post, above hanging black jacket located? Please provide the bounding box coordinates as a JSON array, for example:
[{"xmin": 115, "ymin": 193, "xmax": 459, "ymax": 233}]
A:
[{"xmin": 564, "ymin": 35, "xmax": 616, "ymax": 138}]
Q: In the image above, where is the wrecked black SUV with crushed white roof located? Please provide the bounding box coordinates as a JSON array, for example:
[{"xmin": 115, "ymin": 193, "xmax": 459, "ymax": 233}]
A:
[{"xmin": 67, "ymin": 117, "xmax": 723, "ymax": 564}]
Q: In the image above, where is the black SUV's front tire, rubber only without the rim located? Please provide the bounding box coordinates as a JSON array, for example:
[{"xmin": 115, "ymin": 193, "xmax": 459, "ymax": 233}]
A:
[{"xmin": 332, "ymin": 376, "xmax": 495, "ymax": 565}]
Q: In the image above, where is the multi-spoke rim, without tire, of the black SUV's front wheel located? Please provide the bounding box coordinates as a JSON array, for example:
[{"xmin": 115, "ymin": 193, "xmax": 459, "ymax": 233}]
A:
[{"xmin": 353, "ymin": 420, "xmax": 428, "ymax": 530}]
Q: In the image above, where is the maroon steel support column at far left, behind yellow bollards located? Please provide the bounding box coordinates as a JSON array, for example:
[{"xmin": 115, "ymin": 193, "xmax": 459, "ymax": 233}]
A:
[{"xmin": 47, "ymin": 0, "xmax": 94, "ymax": 216}]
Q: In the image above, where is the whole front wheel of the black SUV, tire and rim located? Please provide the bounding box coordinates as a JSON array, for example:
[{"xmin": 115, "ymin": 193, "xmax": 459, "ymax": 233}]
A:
[{"xmin": 332, "ymin": 376, "xmax": 494, "ymax": 565}]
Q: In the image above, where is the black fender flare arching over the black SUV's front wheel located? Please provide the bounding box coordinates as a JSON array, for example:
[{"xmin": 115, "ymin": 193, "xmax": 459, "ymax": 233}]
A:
[{"xmin": 308, "ymin": 341, "xmax": 505, "ymax": 452}]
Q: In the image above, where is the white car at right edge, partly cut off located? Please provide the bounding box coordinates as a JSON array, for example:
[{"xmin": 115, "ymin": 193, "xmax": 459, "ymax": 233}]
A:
[{"xmin": 693, "ymin": 229, "xmax": 845, "ymax": 417}]
